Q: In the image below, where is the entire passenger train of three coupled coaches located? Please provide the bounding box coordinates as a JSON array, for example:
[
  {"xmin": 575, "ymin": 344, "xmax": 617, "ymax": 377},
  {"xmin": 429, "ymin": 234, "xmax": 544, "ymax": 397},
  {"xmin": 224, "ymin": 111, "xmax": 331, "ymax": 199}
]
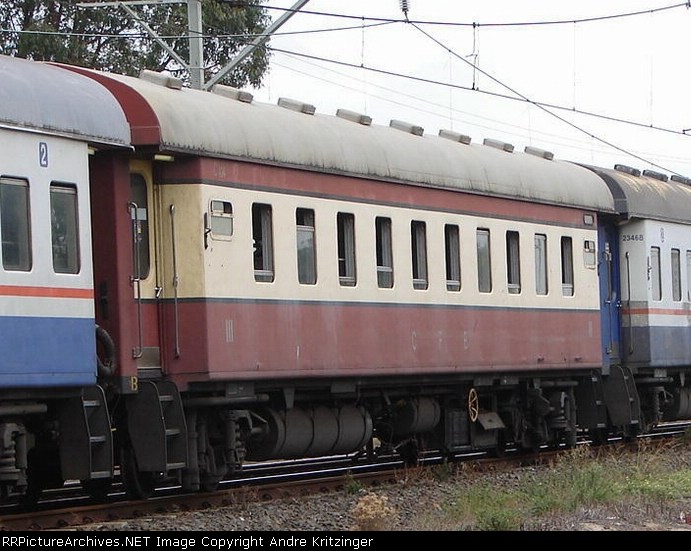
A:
[{"xmin": 0, "ymin": 52, "xmax": 691, "ymax": 504}]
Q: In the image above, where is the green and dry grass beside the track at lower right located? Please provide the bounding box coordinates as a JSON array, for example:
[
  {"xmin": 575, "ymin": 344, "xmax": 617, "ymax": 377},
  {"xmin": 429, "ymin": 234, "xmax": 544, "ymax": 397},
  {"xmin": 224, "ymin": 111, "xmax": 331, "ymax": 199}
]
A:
[{"xmin": 353, "ymin": 432, "xmax": 691, "ymax": 531}]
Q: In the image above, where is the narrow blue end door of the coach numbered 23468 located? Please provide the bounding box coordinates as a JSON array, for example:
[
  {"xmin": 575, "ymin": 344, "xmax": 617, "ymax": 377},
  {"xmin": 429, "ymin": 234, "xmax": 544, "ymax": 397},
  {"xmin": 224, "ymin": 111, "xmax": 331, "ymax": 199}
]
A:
[{"xmin": 598, "ymin": 223, "xmax": 621, "ymax": 376}]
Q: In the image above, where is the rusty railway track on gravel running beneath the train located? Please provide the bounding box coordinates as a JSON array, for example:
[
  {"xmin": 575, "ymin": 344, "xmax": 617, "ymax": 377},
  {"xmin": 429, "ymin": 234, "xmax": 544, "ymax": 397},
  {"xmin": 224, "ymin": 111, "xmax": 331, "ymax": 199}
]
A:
[{"xmin": 0, "ymin": 424, "xmax": 688, "ymax": 531}]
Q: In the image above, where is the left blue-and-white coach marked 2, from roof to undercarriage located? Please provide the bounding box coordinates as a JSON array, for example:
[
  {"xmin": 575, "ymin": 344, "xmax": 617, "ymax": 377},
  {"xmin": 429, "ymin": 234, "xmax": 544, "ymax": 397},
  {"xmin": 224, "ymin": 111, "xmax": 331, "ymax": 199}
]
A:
[{"xmin": 0, "ymin": 56, "xmax": 129, "ymax": 500}]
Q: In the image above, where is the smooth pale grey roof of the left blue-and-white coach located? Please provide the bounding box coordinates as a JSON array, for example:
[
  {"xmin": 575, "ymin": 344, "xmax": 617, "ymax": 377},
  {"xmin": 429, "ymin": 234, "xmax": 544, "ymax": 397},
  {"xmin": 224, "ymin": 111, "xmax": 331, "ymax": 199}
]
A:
[{"xmin": 0, "ymin": 55, "xmax": 130, "ymax": 146}]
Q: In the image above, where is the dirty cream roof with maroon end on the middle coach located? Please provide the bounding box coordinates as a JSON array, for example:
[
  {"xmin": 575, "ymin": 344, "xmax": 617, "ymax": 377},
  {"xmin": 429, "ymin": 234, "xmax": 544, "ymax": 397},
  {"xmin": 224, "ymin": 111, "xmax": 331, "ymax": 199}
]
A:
[{"xmin": 73, "ymin": 68, "xmax": 614, "ymax": 212}]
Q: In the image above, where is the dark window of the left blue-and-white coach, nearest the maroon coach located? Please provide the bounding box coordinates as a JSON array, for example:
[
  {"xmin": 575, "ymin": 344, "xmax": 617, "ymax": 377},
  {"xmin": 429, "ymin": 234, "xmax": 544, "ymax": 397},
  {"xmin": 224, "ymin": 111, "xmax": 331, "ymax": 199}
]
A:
[{"xmin": 50, "ymin": 184, "xmax": 79, "ymax": 274}]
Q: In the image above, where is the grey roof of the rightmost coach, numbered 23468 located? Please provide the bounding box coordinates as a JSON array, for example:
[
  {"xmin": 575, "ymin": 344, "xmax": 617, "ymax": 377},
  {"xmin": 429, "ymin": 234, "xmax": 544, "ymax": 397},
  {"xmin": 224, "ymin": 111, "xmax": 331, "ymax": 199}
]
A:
[{"xmin": 588, "ymin": 165, "xmax": 691, "ymax": 224}]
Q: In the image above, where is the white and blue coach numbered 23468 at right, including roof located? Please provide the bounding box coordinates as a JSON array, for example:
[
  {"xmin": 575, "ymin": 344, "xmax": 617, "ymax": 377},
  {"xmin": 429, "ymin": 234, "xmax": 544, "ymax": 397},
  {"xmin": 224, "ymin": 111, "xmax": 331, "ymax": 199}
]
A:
[{"xmin": 593, "ymin": 165, "xmax": 691, "ymax": 425}]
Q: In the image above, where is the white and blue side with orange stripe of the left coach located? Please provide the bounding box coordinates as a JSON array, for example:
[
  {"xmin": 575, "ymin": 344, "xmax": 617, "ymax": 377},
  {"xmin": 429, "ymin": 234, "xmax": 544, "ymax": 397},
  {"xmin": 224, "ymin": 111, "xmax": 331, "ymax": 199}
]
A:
[{"xmin": 0, "ymin": 129, "xmax": 96, "ymax": 388}]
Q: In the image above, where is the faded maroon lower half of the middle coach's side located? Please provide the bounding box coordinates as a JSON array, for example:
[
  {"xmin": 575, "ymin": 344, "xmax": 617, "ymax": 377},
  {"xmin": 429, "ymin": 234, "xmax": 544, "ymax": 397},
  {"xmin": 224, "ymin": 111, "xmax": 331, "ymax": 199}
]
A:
[{"xmin": 151, "ymin": 301, "xmax": 601, "ymax": 385}]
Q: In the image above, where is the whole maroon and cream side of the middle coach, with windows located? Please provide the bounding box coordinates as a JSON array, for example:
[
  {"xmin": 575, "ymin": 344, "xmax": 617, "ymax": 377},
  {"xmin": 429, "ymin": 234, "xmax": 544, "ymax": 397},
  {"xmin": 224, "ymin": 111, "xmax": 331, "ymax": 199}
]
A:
[{"xmin": 147, "ymin": 157, "xmax": 601, "ymax": 381}]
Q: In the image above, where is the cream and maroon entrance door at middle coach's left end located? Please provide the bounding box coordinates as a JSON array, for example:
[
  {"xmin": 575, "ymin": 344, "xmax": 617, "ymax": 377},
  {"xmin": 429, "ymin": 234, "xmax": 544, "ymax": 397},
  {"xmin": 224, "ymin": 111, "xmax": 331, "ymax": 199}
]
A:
[{"xmin": 129, "ymin": 165, "xmax": 161, "ymax": 376}]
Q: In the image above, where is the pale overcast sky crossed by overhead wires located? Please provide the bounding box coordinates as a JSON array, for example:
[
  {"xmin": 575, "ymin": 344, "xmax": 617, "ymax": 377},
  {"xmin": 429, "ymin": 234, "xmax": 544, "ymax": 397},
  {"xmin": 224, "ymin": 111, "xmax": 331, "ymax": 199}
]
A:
[{"xmin": 242, "ymin": 0, "xmax": 691, "ymax": 177}]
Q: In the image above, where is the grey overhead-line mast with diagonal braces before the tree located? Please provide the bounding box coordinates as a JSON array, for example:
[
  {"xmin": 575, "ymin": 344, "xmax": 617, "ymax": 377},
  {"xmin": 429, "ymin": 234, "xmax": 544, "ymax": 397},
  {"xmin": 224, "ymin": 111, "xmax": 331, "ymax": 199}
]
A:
[{"xmin": 77, "ymin": 0, "xmax": 309, "ymax": 90}]
